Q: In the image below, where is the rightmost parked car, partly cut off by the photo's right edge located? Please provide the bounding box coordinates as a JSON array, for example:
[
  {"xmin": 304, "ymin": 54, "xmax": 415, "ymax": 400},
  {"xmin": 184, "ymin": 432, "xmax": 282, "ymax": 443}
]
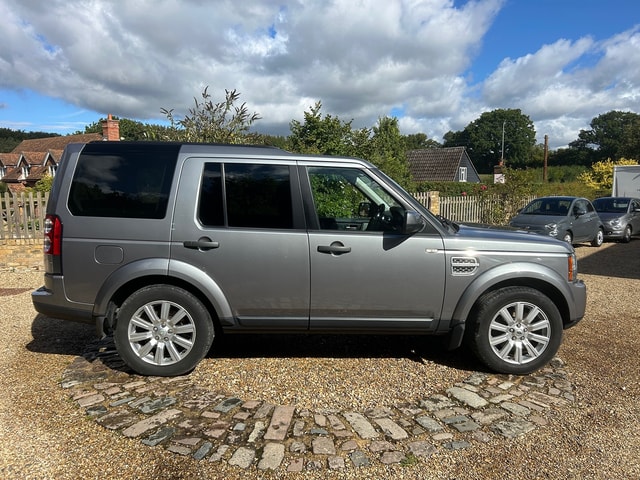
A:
[{"xmin": 593, "ymin": 197, "xmax": 640, "ymax": 243}]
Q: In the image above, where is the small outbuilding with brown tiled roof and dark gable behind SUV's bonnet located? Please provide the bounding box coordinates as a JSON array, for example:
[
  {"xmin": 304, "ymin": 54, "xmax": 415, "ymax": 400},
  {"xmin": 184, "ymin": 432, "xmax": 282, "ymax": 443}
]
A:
[{"xmin": 407, "ymin": 147, "xmax": 480, "ymax": 183}]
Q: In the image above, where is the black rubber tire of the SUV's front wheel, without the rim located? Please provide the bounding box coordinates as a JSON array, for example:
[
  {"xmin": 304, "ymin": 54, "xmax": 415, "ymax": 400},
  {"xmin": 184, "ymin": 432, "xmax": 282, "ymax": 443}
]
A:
[{"xmin": 469, "ymin": 287, "xmax": 563, "ymax": 375}]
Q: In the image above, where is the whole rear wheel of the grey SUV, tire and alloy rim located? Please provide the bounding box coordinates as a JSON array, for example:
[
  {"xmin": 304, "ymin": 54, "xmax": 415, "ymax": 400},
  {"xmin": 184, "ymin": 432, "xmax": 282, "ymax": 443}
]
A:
[{"xmin": 114, "ymin": 285, "xmax": 214, "ymax": 377}]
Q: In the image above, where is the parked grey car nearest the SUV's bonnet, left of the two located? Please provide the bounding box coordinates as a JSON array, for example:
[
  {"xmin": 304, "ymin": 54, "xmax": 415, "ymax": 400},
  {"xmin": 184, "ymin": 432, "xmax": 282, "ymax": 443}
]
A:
[{"xmin": 509, "ymin": 197, "xmax": 604, "ymax": 247}]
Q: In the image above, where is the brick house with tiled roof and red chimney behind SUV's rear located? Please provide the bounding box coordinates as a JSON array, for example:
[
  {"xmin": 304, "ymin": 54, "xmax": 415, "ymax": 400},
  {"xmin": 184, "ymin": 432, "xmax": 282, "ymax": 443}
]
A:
[{"xmin": 0, "ymin": 115, "xmax": 120, "ymax": 193}]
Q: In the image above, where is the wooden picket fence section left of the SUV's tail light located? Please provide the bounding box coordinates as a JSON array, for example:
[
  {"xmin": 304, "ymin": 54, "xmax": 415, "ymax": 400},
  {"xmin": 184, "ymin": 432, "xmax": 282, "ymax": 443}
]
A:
[{"xmin": 0, "ymin": 192, "xmax": 49, "ymax": 240}]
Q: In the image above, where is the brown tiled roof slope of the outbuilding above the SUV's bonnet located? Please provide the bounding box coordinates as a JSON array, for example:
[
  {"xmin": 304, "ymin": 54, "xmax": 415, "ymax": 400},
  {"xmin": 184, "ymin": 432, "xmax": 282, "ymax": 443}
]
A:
[{"xmin": 407, "ymin": 147, "xmax": 466, "ymax": 182}]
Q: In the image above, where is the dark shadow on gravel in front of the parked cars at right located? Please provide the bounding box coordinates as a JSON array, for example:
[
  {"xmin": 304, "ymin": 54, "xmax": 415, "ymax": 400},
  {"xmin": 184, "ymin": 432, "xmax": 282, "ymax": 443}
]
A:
[{"xmin": 575, "ymin": 238, "xmax": 640, "ymax": 279}]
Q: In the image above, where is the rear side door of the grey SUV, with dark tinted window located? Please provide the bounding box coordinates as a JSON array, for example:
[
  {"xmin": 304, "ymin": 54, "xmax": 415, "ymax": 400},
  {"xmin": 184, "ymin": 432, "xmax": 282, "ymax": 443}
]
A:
[{"xmin": 171, "ymin": 158, "xmax": 309, "ymax": 330}]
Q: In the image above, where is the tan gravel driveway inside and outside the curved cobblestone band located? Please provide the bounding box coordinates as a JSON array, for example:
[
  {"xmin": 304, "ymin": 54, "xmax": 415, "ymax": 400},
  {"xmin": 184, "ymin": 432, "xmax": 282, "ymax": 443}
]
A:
[{"xmin": 0, "ymin": 240, "xmax": 640, "ymax": 479}]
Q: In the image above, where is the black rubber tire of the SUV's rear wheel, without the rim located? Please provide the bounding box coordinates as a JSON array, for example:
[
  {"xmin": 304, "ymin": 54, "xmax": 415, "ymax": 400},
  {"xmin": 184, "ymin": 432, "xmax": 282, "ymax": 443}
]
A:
[{"xmin": 113, "ymin": 285, "xmax": 214, "ymax": 377}]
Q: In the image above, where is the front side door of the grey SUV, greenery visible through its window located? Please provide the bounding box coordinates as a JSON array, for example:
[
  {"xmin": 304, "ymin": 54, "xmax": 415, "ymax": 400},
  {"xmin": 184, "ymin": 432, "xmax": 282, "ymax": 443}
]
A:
[{"xmin": 302, "ymin": 165, "xmax": 446, "ymax": 332}]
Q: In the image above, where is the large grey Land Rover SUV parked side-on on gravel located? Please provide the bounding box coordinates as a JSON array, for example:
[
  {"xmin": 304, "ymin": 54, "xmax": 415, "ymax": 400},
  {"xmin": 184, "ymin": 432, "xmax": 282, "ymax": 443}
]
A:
[{"xmin": 32, "ymin": 142, "xmax": 586, "ymax": 376}]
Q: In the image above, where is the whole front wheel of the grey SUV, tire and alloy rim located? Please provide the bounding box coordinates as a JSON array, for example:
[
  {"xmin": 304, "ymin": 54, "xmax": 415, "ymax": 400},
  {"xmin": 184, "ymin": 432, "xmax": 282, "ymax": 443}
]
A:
[{"xmin": 467, "ymin": 287, "xmax": 563, "ymax": 375}]
